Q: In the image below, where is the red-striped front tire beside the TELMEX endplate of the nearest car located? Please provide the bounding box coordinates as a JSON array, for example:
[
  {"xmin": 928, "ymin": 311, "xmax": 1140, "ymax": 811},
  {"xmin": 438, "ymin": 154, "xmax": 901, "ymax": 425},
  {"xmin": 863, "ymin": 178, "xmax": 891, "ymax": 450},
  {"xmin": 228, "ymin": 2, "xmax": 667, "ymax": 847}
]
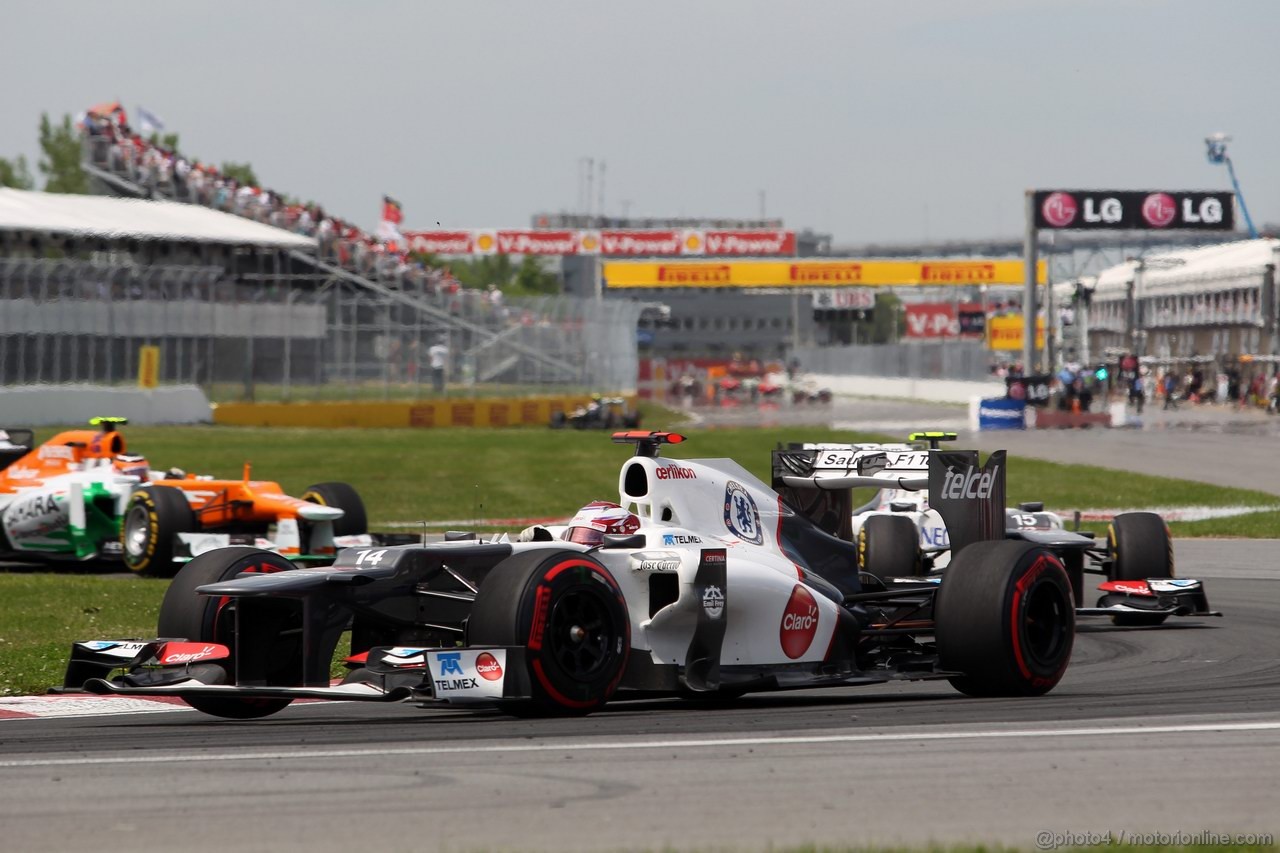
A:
[{"xmin": 467, "ymin": 551, "xmax": 631, "ymax": 716}]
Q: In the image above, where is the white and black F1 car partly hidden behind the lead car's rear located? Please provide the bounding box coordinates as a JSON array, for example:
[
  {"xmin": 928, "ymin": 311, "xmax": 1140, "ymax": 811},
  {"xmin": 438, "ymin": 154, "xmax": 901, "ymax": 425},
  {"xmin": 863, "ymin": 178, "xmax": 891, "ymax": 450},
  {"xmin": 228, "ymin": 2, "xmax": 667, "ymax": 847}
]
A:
[{"xmin": 773, "ymin": 432, "xmax": 1221, "ymax": 626}]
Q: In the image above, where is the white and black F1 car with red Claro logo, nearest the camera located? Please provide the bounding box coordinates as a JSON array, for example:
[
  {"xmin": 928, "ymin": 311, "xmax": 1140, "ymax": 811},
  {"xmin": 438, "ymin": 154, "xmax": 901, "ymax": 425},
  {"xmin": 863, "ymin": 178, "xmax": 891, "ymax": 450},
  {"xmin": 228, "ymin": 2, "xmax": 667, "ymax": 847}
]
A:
[{"xmin": 65, "ymin": 432, "xmax": 1075, "ymax": 719}]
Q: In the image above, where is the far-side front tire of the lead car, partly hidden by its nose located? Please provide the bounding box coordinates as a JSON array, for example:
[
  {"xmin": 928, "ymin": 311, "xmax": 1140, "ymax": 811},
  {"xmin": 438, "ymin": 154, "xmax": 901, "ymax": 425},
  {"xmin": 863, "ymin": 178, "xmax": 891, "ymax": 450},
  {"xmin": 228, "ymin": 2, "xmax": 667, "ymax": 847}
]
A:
[{"xmin": 156, "ymin": 546, "xmax": 302, "ymax": 720}]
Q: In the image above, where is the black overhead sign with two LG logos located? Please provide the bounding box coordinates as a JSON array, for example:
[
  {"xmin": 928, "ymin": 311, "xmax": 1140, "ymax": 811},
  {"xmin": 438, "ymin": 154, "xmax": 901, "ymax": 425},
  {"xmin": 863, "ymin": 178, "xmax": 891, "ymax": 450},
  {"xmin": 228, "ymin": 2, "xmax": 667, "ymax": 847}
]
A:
[{"xmin": 1036, "ymin": 190, "xmax": 1235, "ymax": 231}]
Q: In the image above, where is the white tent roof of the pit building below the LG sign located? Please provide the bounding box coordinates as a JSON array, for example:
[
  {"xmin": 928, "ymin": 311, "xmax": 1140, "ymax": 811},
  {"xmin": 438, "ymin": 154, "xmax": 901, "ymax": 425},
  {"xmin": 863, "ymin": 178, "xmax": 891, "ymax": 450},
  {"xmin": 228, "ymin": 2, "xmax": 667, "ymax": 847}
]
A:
[{"xmin": 1080, "ymin": 237, "xmax": 1280, "ymax": 298}]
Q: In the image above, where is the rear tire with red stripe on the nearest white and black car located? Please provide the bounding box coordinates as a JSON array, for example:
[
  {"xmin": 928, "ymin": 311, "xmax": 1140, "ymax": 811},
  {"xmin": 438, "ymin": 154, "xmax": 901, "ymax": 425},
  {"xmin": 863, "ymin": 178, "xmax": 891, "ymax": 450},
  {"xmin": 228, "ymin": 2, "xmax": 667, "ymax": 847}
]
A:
[{"xmin": 933, "ymin": 540, "xmax": 1075, "ymax": 697}]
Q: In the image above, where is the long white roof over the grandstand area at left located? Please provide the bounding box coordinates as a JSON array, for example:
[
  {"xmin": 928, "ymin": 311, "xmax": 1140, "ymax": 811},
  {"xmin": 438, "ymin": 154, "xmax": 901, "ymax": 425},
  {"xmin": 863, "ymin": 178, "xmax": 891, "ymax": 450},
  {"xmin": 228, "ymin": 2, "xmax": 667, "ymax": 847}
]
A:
[{"xmin": 0, "ymin": 188, "xmax": 316, "ymax": 248}]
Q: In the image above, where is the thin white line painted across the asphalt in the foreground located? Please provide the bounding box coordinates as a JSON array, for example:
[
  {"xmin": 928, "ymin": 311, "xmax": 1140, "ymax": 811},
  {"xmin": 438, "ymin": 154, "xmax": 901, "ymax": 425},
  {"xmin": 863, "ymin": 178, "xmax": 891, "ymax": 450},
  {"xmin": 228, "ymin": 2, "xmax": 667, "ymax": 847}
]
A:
[{"xmin": 0, "ymin": 722, "xmax": 1280, "ymax": 770}]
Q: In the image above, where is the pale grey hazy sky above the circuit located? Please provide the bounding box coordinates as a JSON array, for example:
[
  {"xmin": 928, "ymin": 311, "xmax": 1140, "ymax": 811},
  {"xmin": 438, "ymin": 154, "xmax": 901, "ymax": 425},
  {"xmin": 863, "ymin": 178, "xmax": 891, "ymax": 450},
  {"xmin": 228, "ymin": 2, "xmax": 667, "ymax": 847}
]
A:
[{"xmin": 0, "ymin": 0, "xmax": 1280, "ymax": 245}]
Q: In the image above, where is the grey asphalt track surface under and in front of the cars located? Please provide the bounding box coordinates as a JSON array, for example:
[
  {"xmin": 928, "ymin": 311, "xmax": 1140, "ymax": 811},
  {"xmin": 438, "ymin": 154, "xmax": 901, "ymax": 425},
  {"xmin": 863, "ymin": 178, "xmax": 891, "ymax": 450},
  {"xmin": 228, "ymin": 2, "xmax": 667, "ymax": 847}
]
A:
[{"xmin": 0, "ymin": 403, "xmax": 1280, "ymax": 852}]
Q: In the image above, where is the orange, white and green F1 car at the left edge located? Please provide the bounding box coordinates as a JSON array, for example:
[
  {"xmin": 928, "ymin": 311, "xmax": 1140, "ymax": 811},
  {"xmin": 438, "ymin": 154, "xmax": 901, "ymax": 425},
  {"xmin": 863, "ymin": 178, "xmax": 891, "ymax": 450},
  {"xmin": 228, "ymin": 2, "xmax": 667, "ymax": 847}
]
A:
[{"xmin": 0, "ymin": 418, "xmax": 374, "ymax": 578}]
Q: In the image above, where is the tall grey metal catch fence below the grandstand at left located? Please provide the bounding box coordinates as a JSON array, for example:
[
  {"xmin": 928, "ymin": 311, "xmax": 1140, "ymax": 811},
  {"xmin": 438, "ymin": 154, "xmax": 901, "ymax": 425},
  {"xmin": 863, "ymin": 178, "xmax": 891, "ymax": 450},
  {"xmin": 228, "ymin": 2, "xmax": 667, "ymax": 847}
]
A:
[{"xmin": 0, "ymin": 256, "xmax": 641, "ymax": 401}]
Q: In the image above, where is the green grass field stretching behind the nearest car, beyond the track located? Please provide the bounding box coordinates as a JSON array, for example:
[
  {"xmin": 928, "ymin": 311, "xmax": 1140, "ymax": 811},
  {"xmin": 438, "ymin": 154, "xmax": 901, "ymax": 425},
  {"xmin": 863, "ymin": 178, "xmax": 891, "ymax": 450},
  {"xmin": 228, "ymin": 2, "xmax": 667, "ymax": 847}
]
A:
[{"xmin": 77, "ymin": 416, "xmax": 1276, "ymax": 527}]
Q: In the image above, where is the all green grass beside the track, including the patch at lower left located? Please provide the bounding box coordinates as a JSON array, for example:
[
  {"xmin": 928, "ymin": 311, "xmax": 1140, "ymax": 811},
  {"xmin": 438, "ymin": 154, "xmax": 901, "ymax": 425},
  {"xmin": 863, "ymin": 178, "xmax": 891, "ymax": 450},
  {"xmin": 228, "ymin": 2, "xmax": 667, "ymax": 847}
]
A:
[{"xmin": 0, "ymin": 409, "xmax": 1280, "ymax": 694}]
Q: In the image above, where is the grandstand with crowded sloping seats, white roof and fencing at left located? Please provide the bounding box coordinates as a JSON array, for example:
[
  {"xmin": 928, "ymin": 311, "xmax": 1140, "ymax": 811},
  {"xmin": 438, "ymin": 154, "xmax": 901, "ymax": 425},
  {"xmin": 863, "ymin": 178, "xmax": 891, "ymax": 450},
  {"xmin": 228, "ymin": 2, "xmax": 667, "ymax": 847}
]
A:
[{"xmin": 0, "ymin": 117, "xmax": 641, "ymax": 400}]
